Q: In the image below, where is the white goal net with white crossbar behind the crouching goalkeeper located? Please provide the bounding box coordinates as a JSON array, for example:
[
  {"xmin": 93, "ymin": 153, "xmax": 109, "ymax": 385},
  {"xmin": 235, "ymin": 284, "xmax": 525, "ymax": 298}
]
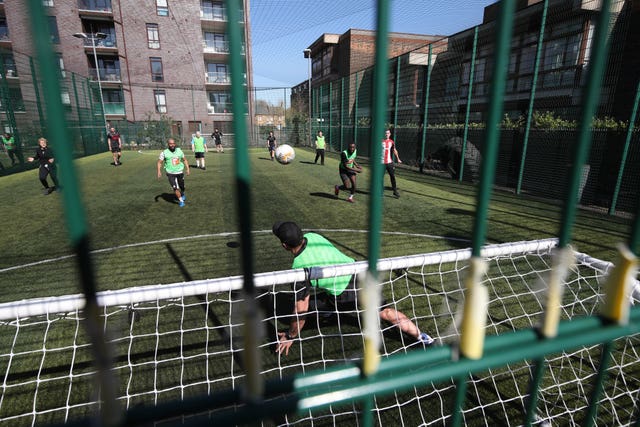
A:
[{"xmin": 0, "ymin": 239, "xmax": 640, "ymax": 425}]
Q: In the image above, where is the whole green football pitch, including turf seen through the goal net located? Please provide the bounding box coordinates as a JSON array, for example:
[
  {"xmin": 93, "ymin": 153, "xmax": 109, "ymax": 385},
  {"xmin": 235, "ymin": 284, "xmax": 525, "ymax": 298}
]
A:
[{"xmin": 0, "ymin": 144, "xmax": 630, "ymax": 425}]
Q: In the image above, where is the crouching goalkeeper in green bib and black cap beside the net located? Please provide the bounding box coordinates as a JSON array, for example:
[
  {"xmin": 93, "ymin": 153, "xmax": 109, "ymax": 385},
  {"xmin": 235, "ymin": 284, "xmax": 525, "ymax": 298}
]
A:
[{"xmin": 272, "ymin": 222, "xmax": 434, "ymax": 355}]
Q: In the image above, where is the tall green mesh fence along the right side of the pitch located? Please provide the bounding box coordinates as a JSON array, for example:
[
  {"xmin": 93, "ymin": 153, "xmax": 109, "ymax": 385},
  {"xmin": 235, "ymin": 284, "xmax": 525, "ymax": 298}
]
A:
[{"xmin": 308, "ymin": 1, "xmax": 640, "ymax": 213}]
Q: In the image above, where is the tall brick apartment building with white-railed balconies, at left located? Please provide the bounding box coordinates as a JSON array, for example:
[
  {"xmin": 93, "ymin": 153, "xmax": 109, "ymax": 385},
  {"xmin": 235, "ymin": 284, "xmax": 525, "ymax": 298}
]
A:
[{"xmin": 0, "ymin": 0, "xmax": 252, "ymax": 135}]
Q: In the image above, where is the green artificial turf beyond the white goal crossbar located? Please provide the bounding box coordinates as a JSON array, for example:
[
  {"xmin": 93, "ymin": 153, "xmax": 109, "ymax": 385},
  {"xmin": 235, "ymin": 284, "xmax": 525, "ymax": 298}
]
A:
[{"xmin": 0, "ymin": 148, "xmax": 629, "ymax": 302}]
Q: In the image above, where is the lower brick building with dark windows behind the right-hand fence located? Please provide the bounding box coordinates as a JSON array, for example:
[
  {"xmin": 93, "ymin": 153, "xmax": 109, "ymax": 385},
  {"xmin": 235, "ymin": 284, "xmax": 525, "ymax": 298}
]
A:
[{"xmin": 291, "ymin": 0, "xmax": 640, "ymax": 130}]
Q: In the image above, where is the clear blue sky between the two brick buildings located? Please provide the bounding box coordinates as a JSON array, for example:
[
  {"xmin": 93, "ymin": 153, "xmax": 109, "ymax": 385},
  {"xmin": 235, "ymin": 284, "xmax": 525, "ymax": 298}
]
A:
[{"xmin": 249, "ymin": 0, "xmax": 497, "ymax": 88}]
